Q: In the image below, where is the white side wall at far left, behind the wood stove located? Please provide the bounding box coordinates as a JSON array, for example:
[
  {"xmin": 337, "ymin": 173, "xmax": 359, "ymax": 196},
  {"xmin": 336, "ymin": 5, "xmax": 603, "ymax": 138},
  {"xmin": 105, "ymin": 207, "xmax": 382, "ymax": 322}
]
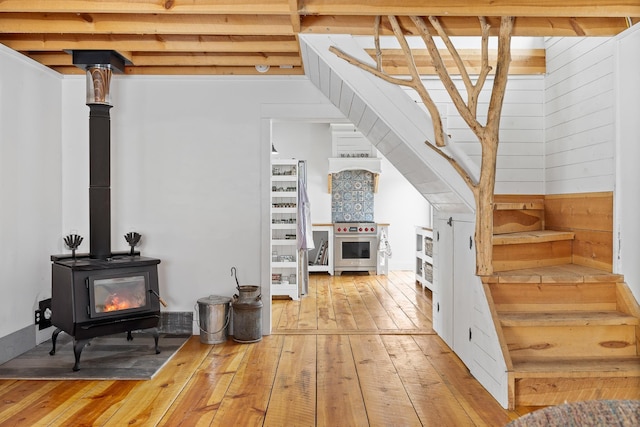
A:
[{"xmin": 0, "ymin": 45, "xmax": 62, "ymax": 348}]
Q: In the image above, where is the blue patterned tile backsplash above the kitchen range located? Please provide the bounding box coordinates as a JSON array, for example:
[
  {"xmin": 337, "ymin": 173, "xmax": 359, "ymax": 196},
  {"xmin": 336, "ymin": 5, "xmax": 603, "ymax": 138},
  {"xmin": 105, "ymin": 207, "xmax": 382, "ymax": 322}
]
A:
[{"xmin": 331, "ymin": 170, "xmax": 373, "ymax": 222}]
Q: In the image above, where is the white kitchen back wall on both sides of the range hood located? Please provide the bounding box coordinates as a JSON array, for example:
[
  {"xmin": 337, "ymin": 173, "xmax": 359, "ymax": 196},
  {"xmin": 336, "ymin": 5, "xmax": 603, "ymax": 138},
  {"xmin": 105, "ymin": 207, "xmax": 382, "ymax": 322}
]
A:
[{"xmin": 273, "ymin": 121, "xmax": 431, "ymax": 270}]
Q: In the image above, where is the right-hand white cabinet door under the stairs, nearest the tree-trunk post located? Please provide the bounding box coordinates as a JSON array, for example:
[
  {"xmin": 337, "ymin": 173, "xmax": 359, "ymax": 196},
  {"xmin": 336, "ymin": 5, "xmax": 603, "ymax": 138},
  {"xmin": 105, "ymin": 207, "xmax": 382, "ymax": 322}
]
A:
[{"xmin": 452, "ymin": 221, "xmax": 477, "ymax": 366}]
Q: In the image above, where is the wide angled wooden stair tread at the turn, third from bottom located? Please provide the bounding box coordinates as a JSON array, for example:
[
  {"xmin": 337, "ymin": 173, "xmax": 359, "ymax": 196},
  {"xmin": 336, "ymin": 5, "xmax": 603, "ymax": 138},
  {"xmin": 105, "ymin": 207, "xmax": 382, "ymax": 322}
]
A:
[{"xmin": 481, "ymin": 264, "xmax": 623, "ymax": 283}]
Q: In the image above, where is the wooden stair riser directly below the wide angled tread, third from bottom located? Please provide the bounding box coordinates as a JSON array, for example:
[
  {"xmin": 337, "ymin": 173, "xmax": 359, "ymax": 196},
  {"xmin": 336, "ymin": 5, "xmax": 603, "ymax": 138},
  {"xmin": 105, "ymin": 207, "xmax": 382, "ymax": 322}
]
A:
[{"xmin": 490, "ymin": 283, "xmax": 618, "ymax": 312}]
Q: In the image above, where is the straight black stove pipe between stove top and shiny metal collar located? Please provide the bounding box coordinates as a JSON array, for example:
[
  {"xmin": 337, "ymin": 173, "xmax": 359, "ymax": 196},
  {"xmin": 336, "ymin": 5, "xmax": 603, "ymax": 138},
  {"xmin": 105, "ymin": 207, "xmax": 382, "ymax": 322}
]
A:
[{"xmin": 89, "ymin": 104, "xmax": 111, "ymax": 259}]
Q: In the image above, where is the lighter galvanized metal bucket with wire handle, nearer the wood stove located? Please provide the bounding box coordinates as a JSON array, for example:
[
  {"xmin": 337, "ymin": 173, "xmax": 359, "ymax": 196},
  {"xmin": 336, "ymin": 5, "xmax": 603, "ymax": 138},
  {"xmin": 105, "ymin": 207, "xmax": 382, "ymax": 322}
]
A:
[{"xmin": 197, "ymin": 295, "xmax": 231, "ymax": 344}]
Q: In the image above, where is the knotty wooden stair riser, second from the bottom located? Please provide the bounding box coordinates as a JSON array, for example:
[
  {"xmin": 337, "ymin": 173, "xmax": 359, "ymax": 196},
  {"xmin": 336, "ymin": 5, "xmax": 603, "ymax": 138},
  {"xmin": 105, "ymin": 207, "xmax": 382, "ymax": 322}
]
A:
[{"xmin": 503, "ymin": 325, "xmax": 638, "ymax": 358}]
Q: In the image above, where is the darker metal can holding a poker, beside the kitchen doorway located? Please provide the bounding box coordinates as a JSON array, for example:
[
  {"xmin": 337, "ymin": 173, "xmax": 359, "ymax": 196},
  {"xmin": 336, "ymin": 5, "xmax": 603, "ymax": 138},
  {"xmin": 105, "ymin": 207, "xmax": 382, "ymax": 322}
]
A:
[{"xmin": 232, "ymin": 286, "xmax": 263, "ymax": 343}]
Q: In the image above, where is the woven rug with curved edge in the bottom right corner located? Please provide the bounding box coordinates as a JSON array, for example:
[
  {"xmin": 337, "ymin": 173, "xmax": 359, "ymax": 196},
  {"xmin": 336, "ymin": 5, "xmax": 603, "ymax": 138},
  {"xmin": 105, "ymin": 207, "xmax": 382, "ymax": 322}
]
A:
[{"xmin": 506, "ymin": 400, "xmax": 640, "ymax": 427}]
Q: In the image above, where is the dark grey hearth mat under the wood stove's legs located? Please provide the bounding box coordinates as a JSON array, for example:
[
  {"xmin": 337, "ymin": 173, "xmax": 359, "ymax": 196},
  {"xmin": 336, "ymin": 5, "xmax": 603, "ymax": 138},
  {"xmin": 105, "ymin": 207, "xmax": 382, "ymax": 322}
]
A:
[{"xmin": 0, "ymin": 333, "xmax": 190, "ymax": 380}]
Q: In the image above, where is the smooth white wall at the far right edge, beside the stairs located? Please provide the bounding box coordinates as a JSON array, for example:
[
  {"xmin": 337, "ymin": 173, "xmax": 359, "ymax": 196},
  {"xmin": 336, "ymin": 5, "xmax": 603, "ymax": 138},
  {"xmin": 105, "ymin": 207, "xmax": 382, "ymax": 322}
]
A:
[{"xmin": 614, "ymin": 25, "xmax": 640, "ymax": 301}]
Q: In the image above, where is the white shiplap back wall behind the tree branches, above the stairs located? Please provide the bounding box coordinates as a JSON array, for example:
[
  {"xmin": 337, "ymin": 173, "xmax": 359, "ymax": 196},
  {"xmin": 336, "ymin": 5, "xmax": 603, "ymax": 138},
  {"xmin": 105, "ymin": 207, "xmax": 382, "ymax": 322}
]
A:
[{"xmin": 406, "ymin": 76, "xmax": 544, "ymax": 194}]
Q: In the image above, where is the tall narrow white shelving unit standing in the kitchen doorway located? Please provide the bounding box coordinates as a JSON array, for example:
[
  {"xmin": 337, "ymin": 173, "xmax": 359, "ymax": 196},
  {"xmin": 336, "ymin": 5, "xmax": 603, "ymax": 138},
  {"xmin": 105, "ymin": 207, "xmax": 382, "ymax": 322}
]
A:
[{"xmin": 271, "ymin": 159, "xmax": 300, "ymax": 300}]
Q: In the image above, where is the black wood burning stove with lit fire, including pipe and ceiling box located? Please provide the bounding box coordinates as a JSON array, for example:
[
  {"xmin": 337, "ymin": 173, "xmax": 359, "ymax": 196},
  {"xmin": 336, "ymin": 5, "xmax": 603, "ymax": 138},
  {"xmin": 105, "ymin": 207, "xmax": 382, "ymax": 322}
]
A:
[{"xmin": 50, "ymin": 51, "xmax": 164, "ymax": 371}]
